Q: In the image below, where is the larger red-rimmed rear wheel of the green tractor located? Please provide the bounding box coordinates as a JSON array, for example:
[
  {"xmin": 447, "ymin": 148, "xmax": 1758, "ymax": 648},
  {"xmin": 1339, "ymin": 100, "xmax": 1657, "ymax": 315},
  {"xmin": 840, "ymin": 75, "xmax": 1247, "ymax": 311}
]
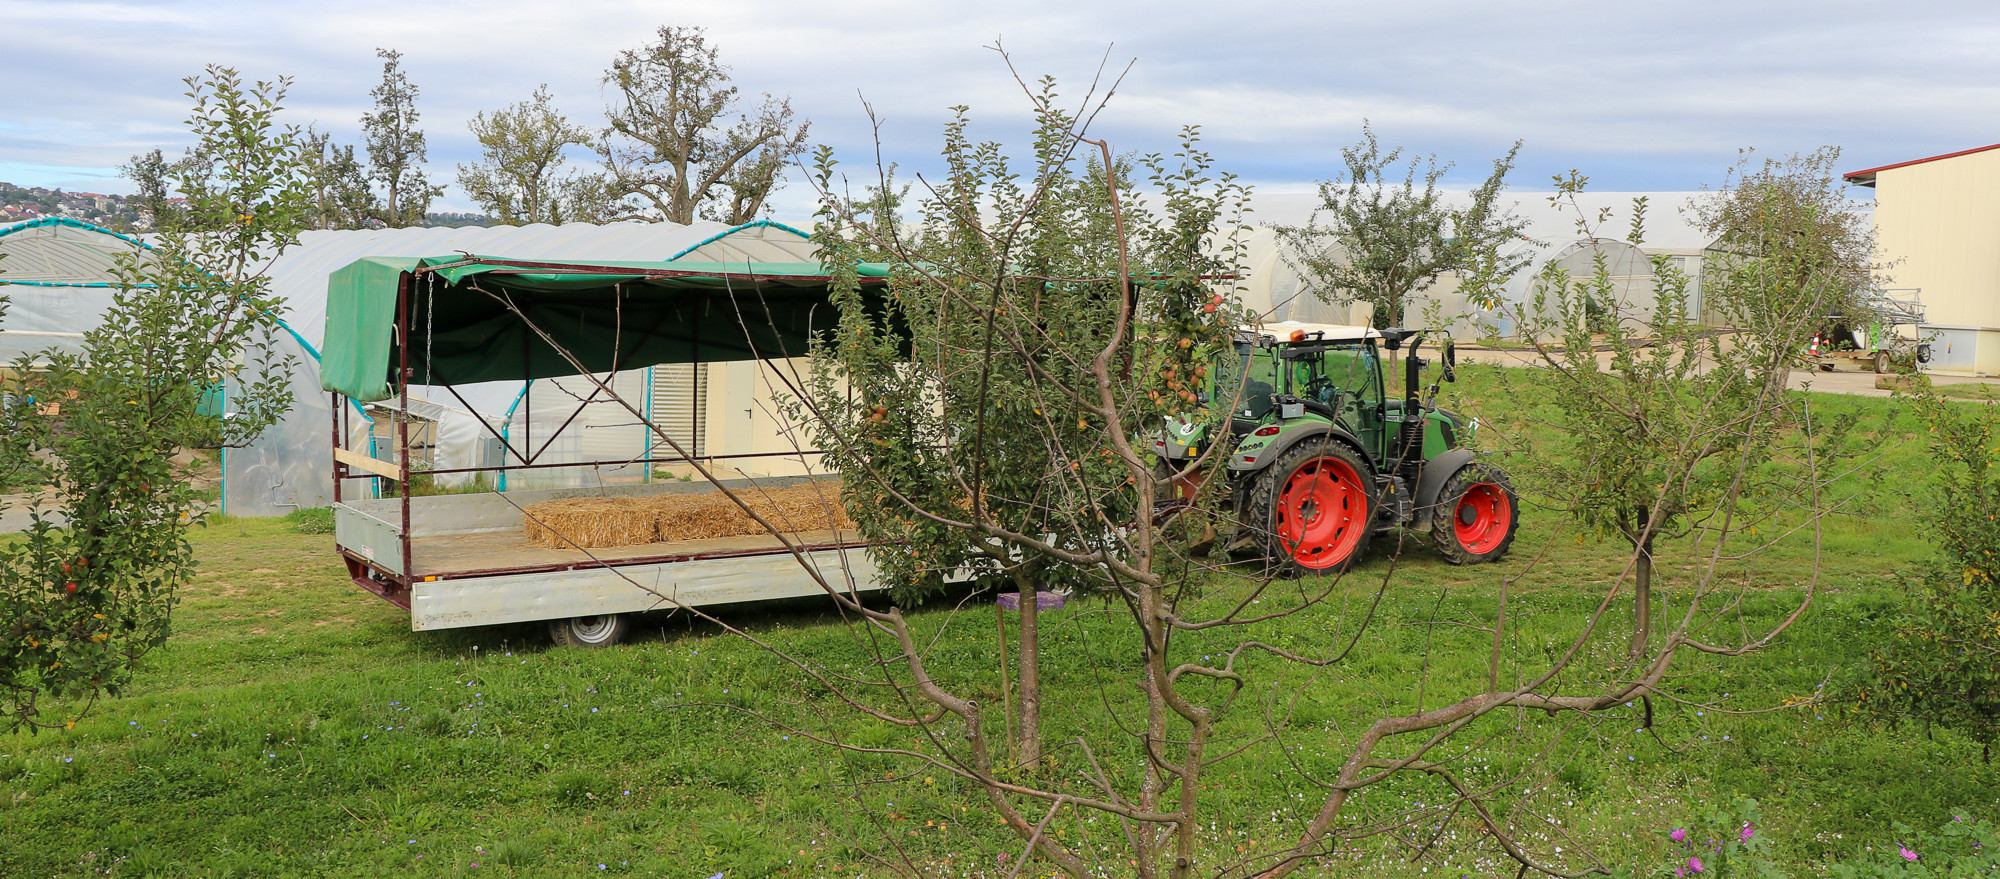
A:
[{"xmin": 1248, "ymin": 438, "xmax": 1376, "ymax": 575}]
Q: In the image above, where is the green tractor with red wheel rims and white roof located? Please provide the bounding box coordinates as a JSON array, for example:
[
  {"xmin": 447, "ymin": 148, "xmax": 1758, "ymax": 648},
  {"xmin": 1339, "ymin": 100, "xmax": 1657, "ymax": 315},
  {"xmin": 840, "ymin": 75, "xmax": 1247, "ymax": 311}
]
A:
[{"xmin": 1154, "ymin": 324, "xmax": 1520, "ymax": 573}]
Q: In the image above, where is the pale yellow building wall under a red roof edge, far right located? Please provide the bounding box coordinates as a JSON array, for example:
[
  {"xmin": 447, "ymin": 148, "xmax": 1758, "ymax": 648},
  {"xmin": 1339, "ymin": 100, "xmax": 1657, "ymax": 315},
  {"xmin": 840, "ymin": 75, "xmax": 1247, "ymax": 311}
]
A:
[{"xmin": 1874, "ymin": 150, "xmax": 2000, "ymax": 374}]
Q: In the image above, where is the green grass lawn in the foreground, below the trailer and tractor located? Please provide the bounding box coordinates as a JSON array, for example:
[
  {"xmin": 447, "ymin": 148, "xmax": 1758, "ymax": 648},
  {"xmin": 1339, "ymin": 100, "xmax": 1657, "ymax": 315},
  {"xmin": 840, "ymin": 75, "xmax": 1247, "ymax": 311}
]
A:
[{"xmin": 0, "ymin": 374, "xmax": 2000, "ymax": 877}]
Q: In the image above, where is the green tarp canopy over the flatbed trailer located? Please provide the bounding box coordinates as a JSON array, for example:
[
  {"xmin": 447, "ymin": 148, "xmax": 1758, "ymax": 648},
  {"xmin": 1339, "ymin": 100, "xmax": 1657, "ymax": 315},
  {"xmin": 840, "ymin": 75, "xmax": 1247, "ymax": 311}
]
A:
[{"xmin": 320, "ymin": 254, "xmax": 888, "ymax": 402}]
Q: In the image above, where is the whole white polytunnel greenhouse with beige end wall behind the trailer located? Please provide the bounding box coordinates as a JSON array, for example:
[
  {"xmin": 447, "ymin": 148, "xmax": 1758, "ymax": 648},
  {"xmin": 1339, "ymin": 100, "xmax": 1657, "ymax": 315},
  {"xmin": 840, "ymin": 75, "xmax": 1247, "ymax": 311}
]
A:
[{"xmin": 222, "ymin": 220, "xmax": 816, "ymax": 515}]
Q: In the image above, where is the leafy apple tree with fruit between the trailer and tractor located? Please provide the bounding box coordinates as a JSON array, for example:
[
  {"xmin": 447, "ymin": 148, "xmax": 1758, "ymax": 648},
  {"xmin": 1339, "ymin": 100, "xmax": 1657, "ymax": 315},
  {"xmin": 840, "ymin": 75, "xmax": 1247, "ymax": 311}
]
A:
[{"xmin": 806, "ymin": 80, "xmax": 1248, "ymax": 765}]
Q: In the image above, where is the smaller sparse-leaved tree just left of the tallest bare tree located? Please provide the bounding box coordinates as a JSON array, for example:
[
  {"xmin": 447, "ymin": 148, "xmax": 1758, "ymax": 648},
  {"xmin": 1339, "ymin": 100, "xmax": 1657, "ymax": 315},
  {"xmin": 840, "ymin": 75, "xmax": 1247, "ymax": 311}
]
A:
[{"xmin": 458, "ymin": 84, "xmax": 608, "ymax": 226}]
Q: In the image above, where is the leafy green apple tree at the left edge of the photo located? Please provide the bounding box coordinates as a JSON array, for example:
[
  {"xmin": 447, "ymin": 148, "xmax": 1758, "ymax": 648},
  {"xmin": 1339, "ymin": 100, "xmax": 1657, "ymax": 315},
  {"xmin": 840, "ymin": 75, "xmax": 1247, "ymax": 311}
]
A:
[{"xmin": 0, "ymin": 66, "xmax": 310, "ymax": 727}]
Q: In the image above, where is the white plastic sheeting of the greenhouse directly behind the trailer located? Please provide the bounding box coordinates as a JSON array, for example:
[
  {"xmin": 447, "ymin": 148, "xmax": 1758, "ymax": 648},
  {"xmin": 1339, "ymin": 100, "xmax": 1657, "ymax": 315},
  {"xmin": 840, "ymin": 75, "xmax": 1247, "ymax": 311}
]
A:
[{"xmin": 222, "ymin": 222, "xmax": 814, "ymax": 515}]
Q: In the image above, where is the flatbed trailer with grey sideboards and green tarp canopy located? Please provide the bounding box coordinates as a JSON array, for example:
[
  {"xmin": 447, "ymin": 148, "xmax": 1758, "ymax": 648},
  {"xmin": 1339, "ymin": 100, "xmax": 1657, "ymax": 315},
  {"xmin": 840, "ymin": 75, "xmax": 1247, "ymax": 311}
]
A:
[{"xmin": 320, "ymin": 254, "xmax": 888, "ymax": 647}]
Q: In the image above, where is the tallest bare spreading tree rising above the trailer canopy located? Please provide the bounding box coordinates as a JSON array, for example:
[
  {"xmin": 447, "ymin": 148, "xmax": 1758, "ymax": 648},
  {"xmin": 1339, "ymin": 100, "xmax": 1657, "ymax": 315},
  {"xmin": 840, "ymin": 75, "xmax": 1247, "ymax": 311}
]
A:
[{"xmin": 598, "ymin": 26, "xmax": 810, "ymax": 224}]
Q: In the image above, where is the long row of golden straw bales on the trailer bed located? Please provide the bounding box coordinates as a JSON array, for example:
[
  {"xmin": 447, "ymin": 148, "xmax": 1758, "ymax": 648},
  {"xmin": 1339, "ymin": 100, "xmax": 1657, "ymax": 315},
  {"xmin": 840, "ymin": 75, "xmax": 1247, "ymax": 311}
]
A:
[{"xmin": 524, "ymin": 481, "xmax": 854, "ymax": 549}]
